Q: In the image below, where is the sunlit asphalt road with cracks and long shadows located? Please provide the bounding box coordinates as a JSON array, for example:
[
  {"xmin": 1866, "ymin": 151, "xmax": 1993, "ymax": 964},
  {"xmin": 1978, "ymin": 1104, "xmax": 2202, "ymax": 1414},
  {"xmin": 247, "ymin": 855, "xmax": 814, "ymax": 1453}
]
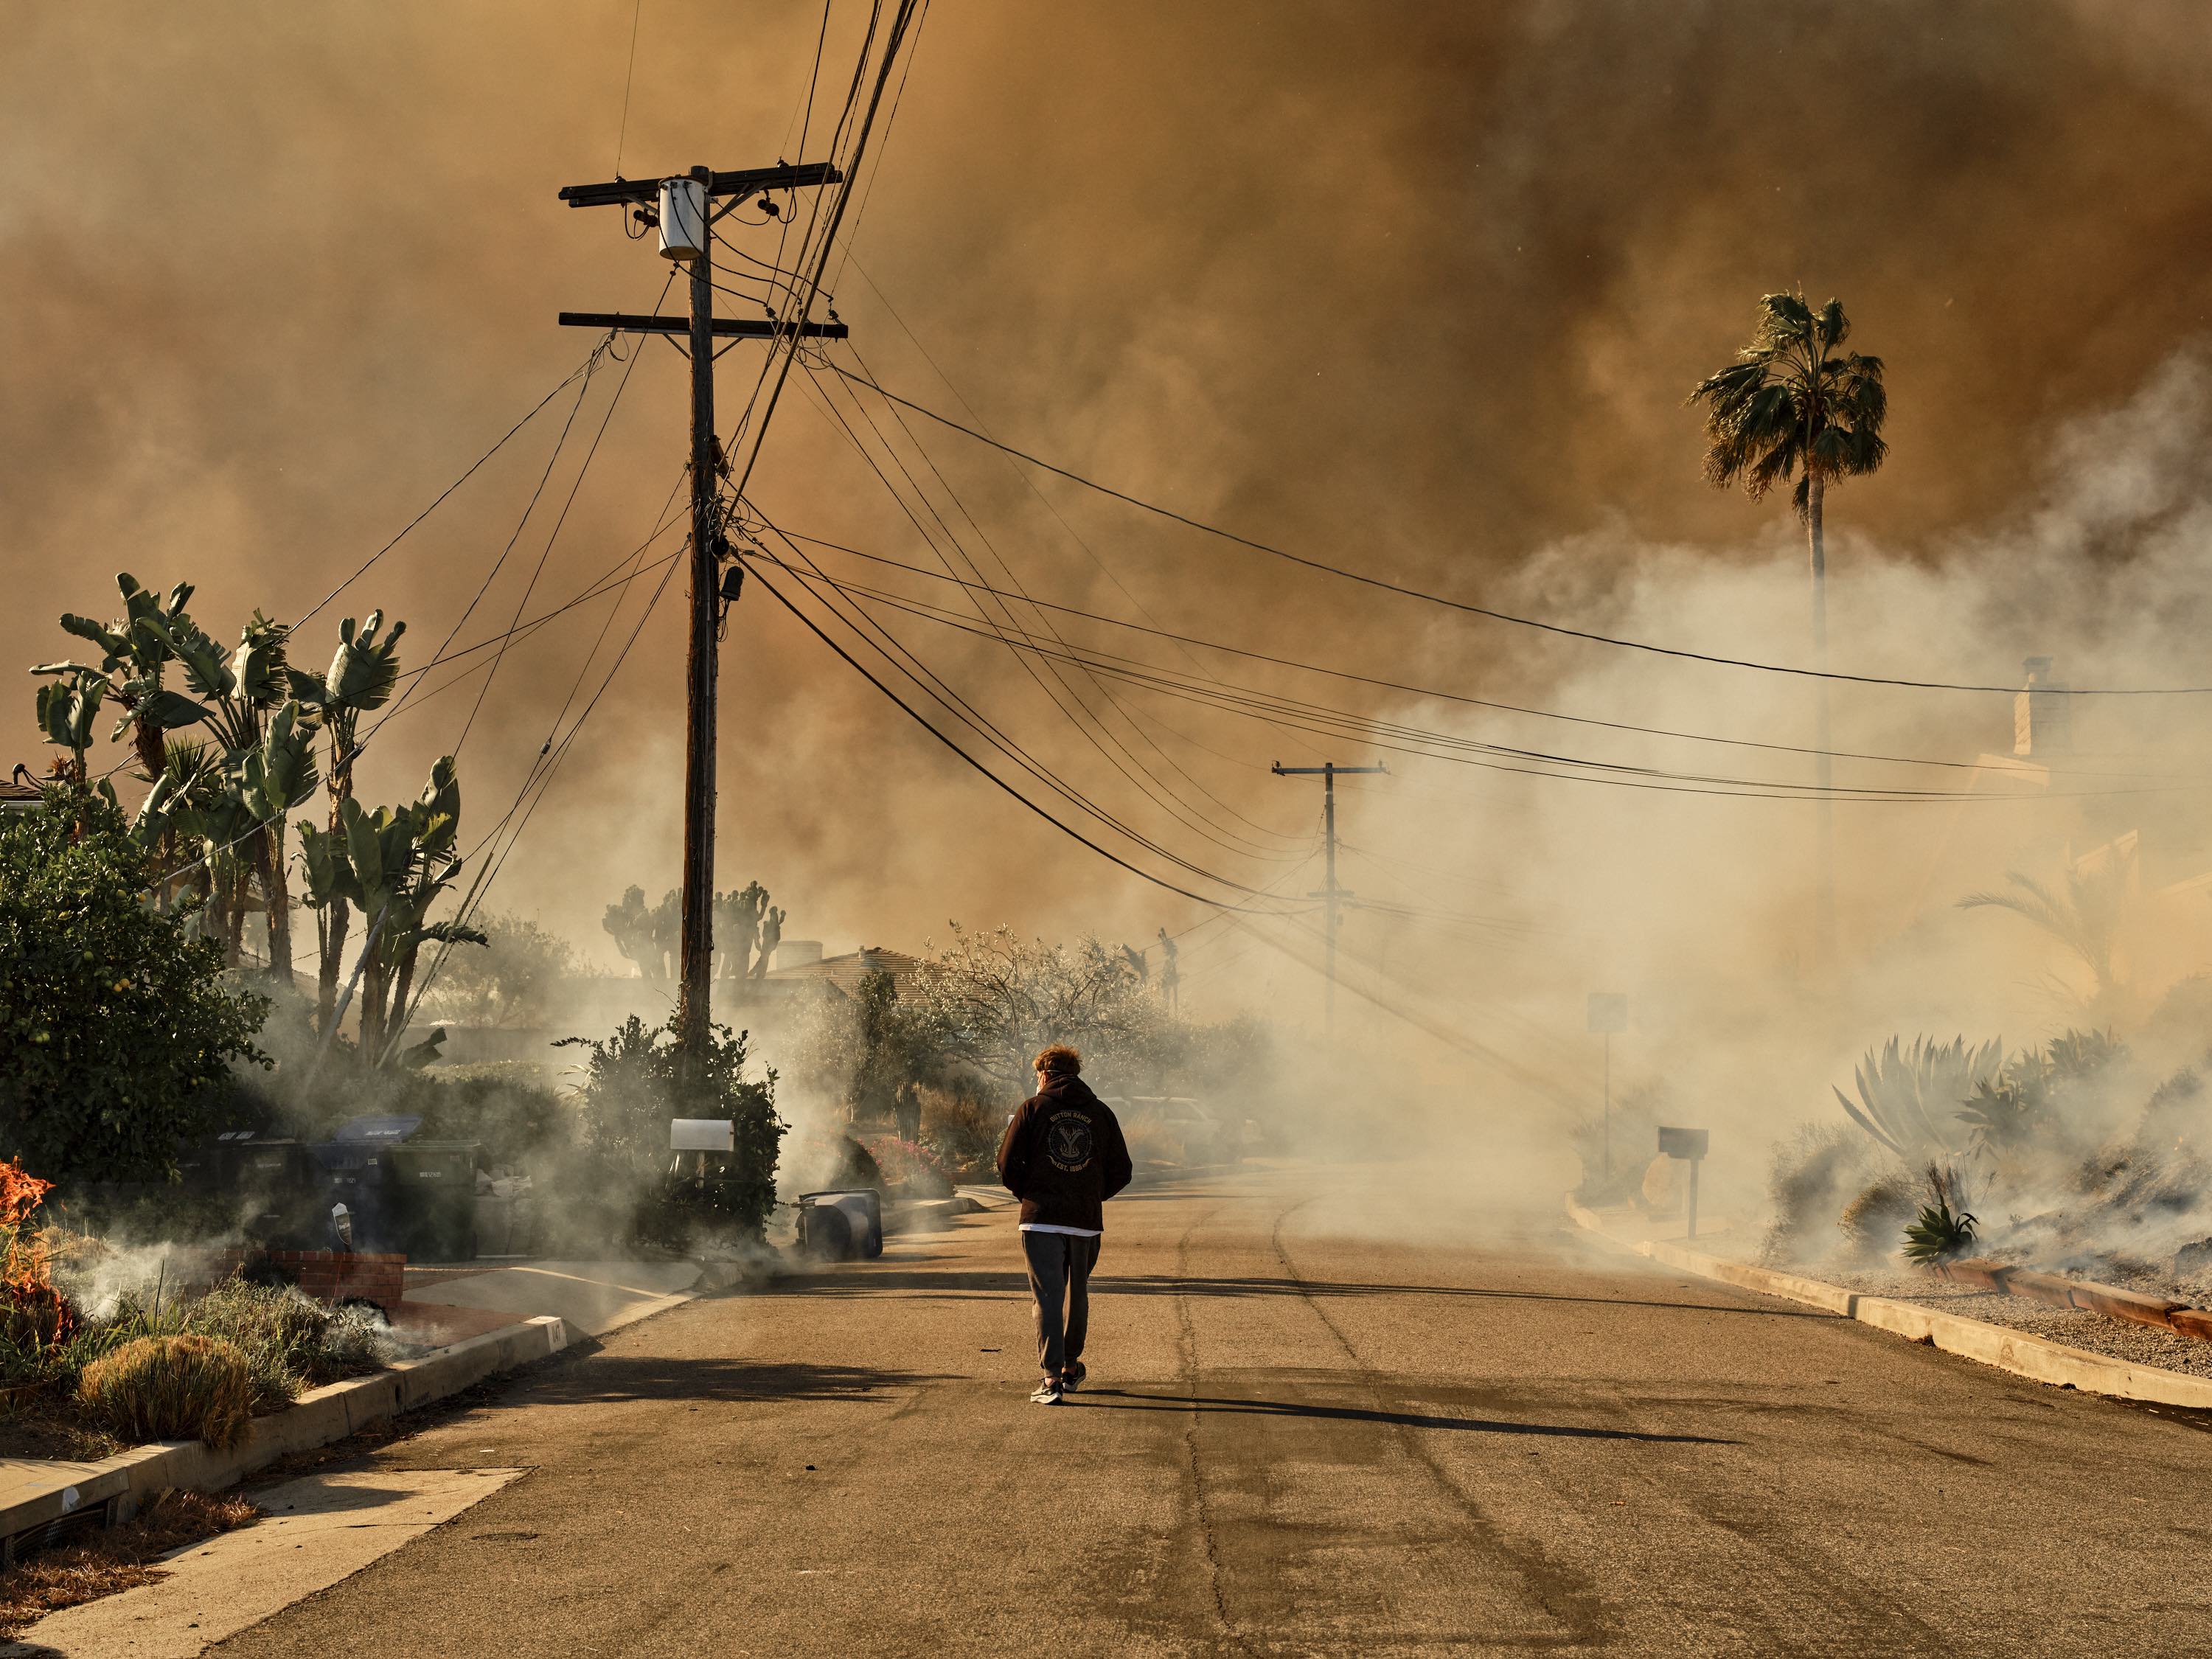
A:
[{"xmin": 212, "ymin": 1168, "xmax": 2212, "ymax": 1659}]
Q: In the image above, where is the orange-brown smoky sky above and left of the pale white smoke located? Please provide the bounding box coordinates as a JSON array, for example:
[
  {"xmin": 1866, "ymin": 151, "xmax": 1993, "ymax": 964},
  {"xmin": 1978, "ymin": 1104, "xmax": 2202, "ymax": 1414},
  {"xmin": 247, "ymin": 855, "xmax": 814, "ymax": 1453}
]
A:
[{"xmin": 0, "ymin": 0, "xmax": 2212, "ymax": 1035}]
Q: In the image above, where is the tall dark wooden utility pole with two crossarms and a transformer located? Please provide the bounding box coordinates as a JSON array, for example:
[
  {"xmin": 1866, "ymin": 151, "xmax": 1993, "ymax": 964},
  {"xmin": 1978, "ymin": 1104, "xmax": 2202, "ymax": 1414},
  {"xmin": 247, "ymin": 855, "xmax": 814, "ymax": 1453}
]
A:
[{"xmin": 560, "ymin": 161, "xmax": 845, "ymax": 1055}]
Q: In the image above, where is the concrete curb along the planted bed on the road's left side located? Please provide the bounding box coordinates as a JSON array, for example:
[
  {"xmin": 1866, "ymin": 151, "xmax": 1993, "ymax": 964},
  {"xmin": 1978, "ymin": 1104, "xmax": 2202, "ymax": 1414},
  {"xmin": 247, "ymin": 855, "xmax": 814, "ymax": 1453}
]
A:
[{"xmin": 0, "ymin": 1316, "xmax": 568, "ymax": 1546}]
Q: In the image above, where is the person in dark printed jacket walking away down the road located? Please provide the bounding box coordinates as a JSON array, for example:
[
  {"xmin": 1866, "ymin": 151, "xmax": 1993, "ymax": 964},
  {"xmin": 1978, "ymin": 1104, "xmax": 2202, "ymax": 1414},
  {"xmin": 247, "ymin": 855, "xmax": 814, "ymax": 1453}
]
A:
[{"xmin": 998, "ymin": 1044, "xmax": 1130, "ymax": 1405}]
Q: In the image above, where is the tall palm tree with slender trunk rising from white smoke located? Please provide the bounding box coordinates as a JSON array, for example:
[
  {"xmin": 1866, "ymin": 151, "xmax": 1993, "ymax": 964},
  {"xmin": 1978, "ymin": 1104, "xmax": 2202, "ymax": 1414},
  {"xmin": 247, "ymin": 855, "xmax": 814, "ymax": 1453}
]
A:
[{"xmin": 1690, "ymin": 294, "xmax": 1889, "ymax": 962}]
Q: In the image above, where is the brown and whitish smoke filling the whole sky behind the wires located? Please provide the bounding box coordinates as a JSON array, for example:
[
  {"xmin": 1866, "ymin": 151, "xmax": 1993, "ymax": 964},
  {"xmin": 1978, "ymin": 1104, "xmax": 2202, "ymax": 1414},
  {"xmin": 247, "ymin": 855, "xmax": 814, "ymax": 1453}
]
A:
[{"xmin": 0, "ymin": 0, "xmax": 2212, "ymax": 1194}]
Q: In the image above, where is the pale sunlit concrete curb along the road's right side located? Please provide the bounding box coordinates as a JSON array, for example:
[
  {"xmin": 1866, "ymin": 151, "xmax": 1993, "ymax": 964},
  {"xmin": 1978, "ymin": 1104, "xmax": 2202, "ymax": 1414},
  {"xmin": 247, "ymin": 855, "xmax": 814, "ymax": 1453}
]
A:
[{"xmin": 1566, "ymin": 1197, "xmax": 2212, "ymax": 1411}]
